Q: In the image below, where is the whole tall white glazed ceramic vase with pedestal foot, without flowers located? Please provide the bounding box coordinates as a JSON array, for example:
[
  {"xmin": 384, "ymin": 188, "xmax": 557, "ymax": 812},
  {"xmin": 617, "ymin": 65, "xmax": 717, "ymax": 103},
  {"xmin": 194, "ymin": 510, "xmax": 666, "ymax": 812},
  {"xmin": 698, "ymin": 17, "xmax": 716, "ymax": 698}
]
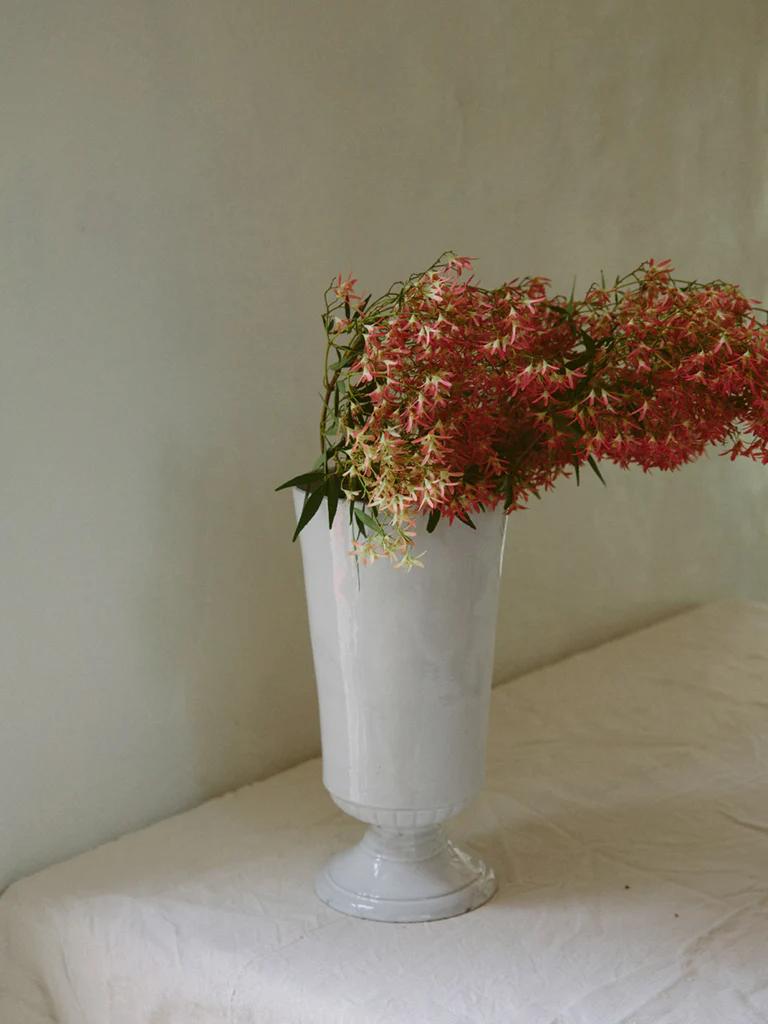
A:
[{"xmin": 294, "ymin": 490, "xmax": 505, "ymax": 922}]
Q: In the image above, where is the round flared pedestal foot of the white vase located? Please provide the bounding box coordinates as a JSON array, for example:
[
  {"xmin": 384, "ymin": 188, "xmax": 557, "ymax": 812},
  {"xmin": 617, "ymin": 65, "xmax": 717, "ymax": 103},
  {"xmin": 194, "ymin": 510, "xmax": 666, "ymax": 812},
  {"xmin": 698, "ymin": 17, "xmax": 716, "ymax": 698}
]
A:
[{"xmin": 314, "ymin": 825, "xmax": 497, "ymax": 924}]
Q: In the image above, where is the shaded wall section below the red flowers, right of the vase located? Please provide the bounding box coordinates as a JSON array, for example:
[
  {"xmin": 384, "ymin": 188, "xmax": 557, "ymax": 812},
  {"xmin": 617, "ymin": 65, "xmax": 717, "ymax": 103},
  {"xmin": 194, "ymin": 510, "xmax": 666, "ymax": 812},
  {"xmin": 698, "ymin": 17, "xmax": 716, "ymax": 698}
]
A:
[{"xmin": 496, "ymin": 452, "xmax": 768, "ymax": 681}]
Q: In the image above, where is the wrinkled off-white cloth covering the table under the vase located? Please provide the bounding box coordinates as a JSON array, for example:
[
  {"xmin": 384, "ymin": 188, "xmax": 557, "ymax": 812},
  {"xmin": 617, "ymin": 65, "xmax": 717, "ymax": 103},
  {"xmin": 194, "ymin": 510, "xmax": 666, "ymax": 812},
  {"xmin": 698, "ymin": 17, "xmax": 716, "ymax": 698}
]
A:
[{"xmin": 0, "ymin": 603, "xmax": 768, "ymax": 1024}]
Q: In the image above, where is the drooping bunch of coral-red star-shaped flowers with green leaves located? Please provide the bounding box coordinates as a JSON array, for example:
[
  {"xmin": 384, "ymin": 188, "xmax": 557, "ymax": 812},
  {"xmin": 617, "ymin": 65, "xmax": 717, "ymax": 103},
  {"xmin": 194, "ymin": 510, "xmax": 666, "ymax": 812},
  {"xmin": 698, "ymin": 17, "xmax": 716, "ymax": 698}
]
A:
[{"xmin": 279, "ymin": 253, "xmax": 768, "ymax": 567}]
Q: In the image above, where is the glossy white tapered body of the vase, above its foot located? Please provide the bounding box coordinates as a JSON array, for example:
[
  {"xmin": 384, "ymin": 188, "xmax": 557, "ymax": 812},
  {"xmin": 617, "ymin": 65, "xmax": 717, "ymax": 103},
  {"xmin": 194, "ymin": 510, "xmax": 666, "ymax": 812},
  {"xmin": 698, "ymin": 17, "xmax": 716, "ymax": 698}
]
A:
[{"xmin": 296, "ymin": 495, "xmax": 505, "ymax": 810}]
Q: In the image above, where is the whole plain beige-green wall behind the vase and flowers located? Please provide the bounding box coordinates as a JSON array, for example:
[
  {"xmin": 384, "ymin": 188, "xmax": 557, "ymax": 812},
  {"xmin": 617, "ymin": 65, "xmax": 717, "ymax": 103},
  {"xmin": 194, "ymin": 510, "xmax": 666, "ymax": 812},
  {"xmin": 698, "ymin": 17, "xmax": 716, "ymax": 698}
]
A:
[{"xmin": 0, "ymin": 0, "xmax": 768, "ymax": 887}]
